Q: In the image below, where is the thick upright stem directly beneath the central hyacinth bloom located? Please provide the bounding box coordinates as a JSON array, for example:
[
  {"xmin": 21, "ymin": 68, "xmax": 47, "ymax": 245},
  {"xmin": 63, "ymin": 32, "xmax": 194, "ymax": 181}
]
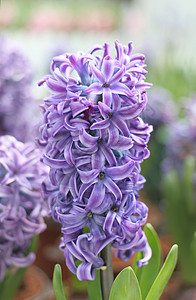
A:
[{"xmin": 101, "ymin": 244, "xmax": 114, "ymax": 300}]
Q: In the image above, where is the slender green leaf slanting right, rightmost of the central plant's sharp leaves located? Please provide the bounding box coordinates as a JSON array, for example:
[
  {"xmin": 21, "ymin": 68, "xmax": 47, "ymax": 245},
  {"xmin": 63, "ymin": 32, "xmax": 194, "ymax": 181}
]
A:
[{"xmin": 146, "ymin": 245, "xmax": 178, "ymax": 300}]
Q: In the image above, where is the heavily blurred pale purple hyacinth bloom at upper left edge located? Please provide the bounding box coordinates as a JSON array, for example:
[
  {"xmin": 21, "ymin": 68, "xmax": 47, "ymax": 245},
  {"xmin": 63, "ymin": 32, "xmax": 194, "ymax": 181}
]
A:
[{"xmin": 0, "ymin": 36, "xmax": 37, "ymax": 142}]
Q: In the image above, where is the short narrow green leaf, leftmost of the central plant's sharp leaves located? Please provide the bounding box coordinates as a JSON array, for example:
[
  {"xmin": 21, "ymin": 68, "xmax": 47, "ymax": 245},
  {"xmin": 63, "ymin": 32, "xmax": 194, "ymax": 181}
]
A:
[{"xmin": 53, "ymin": 264, "xmax": 66, "ymax": 300}]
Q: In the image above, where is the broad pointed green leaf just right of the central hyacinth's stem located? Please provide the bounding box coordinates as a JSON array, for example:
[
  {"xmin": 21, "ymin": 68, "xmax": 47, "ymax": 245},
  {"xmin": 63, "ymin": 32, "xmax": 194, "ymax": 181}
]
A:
[{"xmin": 109, "ymin": 267, "xmax": 142, "ymax": 300}]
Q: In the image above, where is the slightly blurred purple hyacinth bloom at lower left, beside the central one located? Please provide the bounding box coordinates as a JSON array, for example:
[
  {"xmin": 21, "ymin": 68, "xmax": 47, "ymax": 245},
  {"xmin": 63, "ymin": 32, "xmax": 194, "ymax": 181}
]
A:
[{"xmin": 0, "ymin": 135, "xmax": 48, "ymax": 281}]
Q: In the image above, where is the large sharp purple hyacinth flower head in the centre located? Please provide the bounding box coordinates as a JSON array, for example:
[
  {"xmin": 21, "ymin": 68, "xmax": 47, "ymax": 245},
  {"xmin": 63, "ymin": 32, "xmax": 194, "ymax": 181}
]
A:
[{"xmin": 39, "ymin": 41, "xmax": 152, "ymax": 280}]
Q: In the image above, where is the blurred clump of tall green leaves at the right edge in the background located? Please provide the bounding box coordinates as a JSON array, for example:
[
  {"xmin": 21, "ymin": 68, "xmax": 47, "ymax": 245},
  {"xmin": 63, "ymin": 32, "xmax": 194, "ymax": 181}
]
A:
[{"xmin": 163, "ymin": 168, "xmax": 196, "ymax": 284}]
